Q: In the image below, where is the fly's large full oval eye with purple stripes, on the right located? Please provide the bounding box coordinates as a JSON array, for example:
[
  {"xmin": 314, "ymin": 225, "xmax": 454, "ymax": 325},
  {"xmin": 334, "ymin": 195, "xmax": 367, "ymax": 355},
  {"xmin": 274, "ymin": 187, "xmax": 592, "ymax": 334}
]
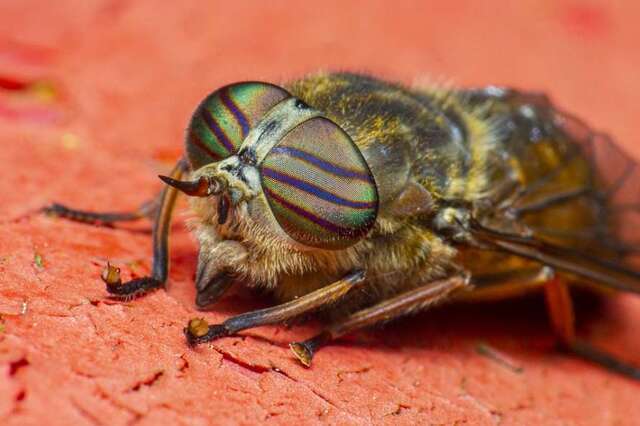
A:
[{"xmin": 260, "ymin": 117, "xmax": 378, "ymax": 250}]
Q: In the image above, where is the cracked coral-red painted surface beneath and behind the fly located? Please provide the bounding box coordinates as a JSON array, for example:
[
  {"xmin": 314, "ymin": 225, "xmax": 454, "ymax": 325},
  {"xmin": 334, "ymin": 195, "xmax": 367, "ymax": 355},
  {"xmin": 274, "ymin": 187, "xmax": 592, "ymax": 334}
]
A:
[{"xmin": 0, "ymin": 0, "xmax": 640, "ymax": 425}]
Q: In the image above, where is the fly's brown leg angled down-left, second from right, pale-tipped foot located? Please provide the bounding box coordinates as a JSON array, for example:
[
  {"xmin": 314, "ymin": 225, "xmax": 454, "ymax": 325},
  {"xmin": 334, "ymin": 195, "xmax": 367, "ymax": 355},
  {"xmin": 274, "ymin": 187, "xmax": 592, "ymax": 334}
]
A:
[{"xmin": 290, "ymin": 275, "xmax": 470, "ymax": 367}]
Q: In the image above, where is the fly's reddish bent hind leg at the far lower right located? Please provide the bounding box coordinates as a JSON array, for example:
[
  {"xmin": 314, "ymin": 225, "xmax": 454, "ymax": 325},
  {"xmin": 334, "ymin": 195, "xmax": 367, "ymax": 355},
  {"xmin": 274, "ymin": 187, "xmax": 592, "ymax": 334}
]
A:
[{"xmin": 544, "ymin": 277, "xmax": 640, "ymax": 380}]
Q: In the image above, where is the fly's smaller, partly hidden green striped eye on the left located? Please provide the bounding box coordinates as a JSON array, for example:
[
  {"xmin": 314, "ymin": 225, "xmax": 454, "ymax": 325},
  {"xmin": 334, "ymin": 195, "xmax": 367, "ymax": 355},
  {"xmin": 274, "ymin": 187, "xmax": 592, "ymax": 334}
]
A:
[{"xmin": 186, "ymin": 82, "xmax": 291, "ymax": 170}]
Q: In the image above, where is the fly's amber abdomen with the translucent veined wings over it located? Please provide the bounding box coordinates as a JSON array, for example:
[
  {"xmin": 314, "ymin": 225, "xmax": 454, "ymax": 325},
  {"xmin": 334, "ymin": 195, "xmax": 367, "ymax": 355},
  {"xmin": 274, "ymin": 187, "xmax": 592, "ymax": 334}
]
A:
[{"xmin": 465, "ymin": 87, "xmax": 640, "ymax": 291}]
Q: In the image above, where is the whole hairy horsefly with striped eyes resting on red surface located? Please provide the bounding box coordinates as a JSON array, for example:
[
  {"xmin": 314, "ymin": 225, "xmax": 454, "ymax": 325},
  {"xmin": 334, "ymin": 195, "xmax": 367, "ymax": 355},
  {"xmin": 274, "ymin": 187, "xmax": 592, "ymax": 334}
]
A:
[{"xmin": 47, "ymin": 73, "xmax": 640, "ymax": 379}]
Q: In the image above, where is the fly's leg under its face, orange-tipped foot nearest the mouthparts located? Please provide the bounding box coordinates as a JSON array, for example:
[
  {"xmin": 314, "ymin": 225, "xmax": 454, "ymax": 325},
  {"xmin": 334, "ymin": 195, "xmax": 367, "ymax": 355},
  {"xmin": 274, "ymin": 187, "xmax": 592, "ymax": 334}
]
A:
[{"xmin": 184, "ymin": 270, "xmax": 365, "ymax": 345}]
